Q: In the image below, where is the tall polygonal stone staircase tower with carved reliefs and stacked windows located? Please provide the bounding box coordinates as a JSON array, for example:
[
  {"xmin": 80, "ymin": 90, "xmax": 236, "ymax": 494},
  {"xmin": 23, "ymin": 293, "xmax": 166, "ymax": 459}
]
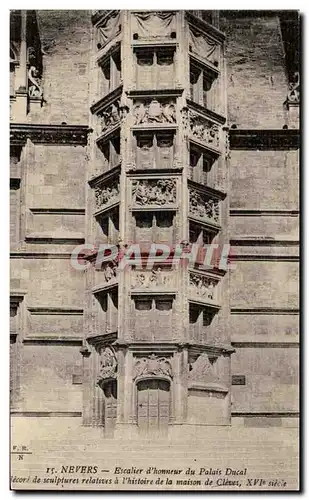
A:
[{"xmin": 81, "ymin": 11, "xmax": 233, "ymax": 437}]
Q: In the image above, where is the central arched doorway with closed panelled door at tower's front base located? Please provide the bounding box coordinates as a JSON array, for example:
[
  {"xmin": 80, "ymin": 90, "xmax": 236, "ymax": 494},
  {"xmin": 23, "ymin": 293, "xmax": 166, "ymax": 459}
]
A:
[{"xmin": 137, "ymin": 378, "xmax": 170, "ymax": 435}]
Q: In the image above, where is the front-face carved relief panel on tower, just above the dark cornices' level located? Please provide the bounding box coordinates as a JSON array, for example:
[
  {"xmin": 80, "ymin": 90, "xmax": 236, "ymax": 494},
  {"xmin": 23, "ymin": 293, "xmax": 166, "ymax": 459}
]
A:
[{"xmin": 133, "ymin": 99, "xmax": 176, "ymax": 125}]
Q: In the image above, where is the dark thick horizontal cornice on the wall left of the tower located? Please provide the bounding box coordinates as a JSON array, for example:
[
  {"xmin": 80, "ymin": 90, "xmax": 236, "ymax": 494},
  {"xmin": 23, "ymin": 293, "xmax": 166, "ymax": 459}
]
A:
[{"xmin": 10, "ymin": 123, "xmax": 92, "ymax": 146}]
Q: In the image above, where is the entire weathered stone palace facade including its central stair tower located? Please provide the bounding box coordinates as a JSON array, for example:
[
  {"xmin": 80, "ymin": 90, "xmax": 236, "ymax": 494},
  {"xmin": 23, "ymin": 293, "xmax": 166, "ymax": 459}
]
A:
[{"xmin": 10, "ymin": 7, "xmax": 299, "ymax": 438}]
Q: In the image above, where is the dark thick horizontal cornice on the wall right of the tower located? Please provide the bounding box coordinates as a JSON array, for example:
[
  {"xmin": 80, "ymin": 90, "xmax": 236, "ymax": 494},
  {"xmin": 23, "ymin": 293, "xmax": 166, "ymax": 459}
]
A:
[{"xmin": 229, "ymin": 129, "xmax": 300, "ymax": 151}]
